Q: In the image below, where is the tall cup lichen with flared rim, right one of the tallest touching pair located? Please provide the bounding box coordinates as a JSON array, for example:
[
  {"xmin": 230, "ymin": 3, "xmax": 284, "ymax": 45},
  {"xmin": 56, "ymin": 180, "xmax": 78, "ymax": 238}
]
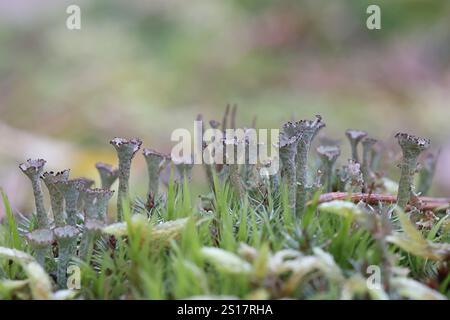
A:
[{"xmin": 295, "ymin": 115, "xmax": 325, "ymax": 215}]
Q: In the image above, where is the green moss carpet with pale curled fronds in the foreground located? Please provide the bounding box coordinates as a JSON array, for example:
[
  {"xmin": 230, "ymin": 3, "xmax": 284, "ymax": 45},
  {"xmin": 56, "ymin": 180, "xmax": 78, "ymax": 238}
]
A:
[{"xmin": 0, "ymin": 116, "xmax": 450, "ymax": 299}]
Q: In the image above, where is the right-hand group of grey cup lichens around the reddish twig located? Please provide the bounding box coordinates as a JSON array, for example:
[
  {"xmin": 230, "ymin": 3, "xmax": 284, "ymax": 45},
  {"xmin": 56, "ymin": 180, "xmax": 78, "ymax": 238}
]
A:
[{"xmin": 279, "ymin": 116, "xmax": 436, "ymax": 216}]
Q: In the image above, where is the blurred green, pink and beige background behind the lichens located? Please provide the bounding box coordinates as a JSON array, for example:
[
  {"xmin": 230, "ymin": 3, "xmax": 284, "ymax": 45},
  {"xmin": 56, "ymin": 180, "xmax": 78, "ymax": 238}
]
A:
[{"xmin": 0, "ymin": 0, "xmax": 450, "ymax": 215}]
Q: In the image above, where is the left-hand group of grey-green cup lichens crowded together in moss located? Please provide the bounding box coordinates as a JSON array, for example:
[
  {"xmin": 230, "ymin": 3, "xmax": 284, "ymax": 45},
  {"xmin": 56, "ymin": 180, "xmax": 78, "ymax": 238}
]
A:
[{"xmin": 19, "ymin": 138, "xmax": 170, "ymax": 288}]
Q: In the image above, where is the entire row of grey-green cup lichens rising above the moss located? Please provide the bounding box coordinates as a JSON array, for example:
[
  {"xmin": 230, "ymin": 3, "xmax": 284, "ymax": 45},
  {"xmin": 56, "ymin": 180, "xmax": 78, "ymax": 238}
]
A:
[{"xmin": 20, "ymin": 114, "xmax": 435, "ymax": 287}]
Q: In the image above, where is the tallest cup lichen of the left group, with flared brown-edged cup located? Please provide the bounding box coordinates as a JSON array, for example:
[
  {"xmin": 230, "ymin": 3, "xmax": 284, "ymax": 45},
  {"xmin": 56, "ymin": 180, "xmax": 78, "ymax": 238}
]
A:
[{"xmin": 110, "ymin": 138, "xmax": 142, "ymax": 221}]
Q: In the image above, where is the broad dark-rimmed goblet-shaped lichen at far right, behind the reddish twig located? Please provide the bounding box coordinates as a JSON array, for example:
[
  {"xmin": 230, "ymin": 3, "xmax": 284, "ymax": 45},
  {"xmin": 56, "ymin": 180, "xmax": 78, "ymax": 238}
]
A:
[{"xmin": 395, "ymin": 133, "xmax": 430, "ymax": 209}]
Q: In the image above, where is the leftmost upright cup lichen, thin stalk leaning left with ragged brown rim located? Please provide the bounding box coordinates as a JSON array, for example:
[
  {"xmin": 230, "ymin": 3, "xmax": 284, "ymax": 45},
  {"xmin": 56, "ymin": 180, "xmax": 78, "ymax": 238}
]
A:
[{"xmin": 19, "ymin": 159, "xmax": 49, "ymax": 228}]
